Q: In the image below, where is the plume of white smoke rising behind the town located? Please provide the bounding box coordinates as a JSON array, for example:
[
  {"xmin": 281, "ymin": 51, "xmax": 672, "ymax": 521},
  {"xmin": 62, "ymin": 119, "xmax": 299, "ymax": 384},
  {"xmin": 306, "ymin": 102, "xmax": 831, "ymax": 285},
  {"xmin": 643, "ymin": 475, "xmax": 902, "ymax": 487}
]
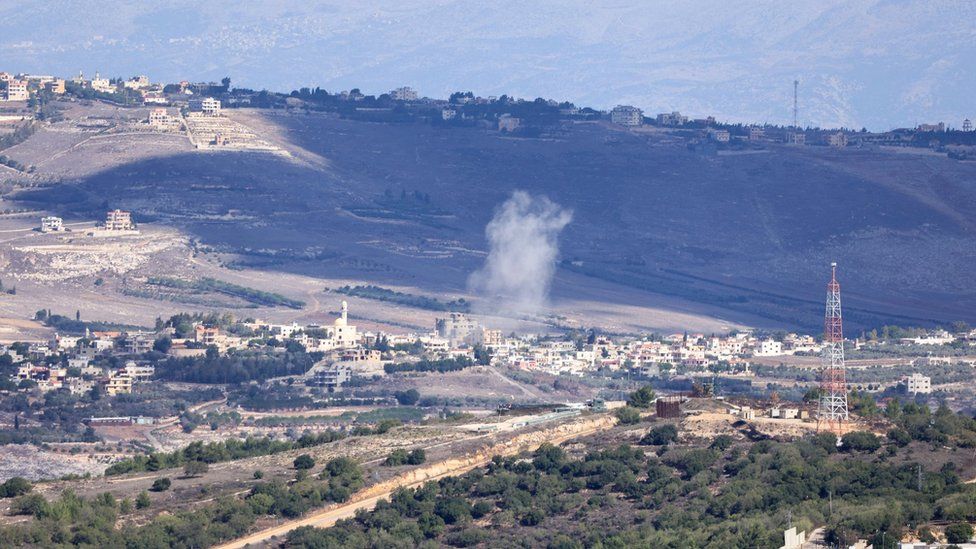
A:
[{"xmin": 468, "ymin": 191, "xmax": 573, "ymax": 315}]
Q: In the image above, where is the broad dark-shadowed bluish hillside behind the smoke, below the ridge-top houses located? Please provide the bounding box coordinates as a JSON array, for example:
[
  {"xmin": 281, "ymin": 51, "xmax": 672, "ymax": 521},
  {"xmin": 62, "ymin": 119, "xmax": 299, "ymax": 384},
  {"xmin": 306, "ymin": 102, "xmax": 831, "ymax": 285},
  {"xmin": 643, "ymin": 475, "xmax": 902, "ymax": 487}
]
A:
[{"xmin": 9, "ymin": 105, "xmax": 976, "ymax": 328}]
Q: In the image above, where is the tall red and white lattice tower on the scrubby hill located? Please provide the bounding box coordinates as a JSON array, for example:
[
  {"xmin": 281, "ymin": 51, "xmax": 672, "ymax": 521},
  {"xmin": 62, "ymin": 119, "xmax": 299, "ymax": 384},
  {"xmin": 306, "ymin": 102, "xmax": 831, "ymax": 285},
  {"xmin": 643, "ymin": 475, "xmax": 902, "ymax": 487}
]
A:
[{"xmin": 817, "ymin": 263, "xmax": 849, "ymax": 435}]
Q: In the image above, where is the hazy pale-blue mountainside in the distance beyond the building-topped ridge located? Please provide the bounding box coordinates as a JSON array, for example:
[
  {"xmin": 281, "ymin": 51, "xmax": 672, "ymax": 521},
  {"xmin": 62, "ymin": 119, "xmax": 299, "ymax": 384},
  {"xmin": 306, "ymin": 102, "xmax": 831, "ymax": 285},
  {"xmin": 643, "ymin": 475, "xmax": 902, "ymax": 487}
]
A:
[{"xmin": 0, "ymin": 0, "xmax": 976, "ymax": 130}]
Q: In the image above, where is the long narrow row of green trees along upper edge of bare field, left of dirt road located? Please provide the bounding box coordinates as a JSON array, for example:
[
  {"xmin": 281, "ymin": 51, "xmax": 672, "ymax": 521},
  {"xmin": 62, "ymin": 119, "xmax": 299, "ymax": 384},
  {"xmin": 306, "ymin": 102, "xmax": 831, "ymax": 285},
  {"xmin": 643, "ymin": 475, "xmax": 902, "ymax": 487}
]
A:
[{"xmin": 105, "ymin": 430, "xmax": 345, "ymax": 476}]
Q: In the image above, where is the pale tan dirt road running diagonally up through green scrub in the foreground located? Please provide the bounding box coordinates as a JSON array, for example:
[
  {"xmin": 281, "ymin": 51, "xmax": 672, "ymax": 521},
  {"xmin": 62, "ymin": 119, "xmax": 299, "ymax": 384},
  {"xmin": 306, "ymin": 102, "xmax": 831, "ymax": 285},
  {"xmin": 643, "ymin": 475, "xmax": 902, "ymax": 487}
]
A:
[{"xmin": 217, "ymin": 416, "xmax": 615, "ymax": 549}]
